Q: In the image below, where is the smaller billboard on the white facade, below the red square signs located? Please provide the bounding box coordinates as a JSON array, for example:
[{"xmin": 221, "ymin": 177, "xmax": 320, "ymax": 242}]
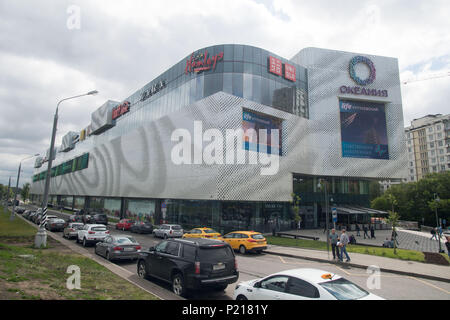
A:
[{"xmin": 242, "ymin": 110, "xmax": 283, "ymax": 156}]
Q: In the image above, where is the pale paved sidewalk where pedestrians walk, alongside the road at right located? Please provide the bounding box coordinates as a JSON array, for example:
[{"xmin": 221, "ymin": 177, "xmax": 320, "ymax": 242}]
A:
[{"xmin": 264, "ymin": 245, "xmax": 450, "ymax": 283}]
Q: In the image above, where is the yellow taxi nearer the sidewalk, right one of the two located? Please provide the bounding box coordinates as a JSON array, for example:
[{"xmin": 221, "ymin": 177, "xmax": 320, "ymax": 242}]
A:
[{"xmin": 220, "ymin": 231, "xmax": 267, "ymax": 254}]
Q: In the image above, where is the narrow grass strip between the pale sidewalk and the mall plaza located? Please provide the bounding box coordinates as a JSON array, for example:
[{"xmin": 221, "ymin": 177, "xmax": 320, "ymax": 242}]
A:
[{"xmin": 266, "ymin": 236, "xmax": 425, "ymax": 262}]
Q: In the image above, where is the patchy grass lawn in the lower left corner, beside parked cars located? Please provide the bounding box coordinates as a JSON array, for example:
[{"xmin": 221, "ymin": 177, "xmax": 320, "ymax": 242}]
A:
[{"xmin": 0, "ymin": 208, "xmax": 157, "ymax": 300}]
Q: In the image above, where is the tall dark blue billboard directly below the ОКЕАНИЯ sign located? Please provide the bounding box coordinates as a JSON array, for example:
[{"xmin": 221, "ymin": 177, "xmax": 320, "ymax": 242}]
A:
[{"xmin": 339, "ymin": 100, "xmax": 389, "ymax": 159}]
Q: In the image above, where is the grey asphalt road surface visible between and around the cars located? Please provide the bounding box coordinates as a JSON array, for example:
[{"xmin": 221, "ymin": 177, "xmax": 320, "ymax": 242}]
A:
[{"xmin": 18, "ymin": 206, "xmax": 450, "ymax": 300}]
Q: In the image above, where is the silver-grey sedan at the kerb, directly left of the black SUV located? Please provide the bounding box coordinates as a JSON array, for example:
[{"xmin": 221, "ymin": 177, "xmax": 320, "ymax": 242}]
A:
[{"xmin": 95, "ymin": 235, "xmax": 142, "ymax": 261}]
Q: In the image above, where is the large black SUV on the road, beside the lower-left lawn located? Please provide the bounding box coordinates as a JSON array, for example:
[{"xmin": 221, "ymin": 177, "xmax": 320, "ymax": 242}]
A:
[{"xmin": 137, "ymin": 238, "xmax": 239, "ymax": 296}]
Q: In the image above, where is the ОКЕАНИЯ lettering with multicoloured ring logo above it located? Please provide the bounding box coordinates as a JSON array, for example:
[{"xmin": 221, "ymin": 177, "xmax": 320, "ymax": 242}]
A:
[{"xmin": 339, "ymin": 56, "xmax": 388, "ymax": 98}]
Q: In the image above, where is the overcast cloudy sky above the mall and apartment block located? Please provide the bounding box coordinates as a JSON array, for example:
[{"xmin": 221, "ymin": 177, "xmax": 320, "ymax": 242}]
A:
[{"xmin": 0, "ymin": 0, "xmax": 450, "ymax": 185}]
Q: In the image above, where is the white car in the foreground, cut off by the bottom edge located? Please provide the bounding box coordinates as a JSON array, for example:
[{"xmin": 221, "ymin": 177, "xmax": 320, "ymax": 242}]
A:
[{"xmin": 233, "ymin": 268, "xmax": 384, "ymax": 300}]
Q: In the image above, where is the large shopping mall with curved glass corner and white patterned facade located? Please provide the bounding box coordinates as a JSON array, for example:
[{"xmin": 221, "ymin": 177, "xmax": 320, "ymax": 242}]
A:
[{"xmin": 31, "ymin": 44, "xmax": 407, "ymax": 232}]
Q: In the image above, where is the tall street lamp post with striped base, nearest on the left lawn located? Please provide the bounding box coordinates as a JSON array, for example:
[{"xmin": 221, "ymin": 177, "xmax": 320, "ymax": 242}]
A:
[{"xmin": 34, "ymin": 90, "xmax": 98, "ymax": 248}]
